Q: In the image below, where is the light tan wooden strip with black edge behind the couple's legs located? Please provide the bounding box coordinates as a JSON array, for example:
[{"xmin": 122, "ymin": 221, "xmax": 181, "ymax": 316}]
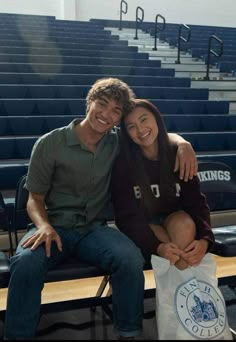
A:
[{"xmin": 0, "ymin": 250, "xmax": 236, "ymax": 338}]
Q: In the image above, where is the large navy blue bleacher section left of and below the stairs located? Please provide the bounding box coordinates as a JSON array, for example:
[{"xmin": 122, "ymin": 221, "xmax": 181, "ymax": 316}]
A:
[{"xmin": 0, "ymin": 10, "xmax": 236, "ymax": 340}]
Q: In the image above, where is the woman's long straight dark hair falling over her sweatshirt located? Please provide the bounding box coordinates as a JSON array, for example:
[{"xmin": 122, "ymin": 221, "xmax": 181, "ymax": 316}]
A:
[{"xmin": 120, "ymin": 99, "xmax": 176, "ymax": 213}]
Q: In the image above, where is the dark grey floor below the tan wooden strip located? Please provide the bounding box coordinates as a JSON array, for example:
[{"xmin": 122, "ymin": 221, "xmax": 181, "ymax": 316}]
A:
[{"xmin": 30, "ymin": 286, "xmax": 236, "ymax": 340}]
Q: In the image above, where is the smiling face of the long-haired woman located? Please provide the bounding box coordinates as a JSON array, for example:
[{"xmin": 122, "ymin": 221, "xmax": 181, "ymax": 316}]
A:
[{"xmin": 124, "ymin": 107, "xmax": 158, "ymax": 148}]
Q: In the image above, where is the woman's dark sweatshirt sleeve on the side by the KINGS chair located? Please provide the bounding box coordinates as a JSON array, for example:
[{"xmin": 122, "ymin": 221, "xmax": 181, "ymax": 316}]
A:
[{"xmin": 181, "ymin": 176, "xmax": 215, "ymax": 251}]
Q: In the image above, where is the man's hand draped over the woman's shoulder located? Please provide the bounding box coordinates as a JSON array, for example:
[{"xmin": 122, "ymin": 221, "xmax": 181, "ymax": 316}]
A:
[{"xmin": 174, "ymin": 141, "xmax": 198, "ymax": 182}]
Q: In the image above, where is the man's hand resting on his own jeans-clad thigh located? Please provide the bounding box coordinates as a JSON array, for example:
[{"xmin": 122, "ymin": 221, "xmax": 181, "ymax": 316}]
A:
[{"xmin": 21, "ymin": 225, "xmax": 62, "ymax": 258}]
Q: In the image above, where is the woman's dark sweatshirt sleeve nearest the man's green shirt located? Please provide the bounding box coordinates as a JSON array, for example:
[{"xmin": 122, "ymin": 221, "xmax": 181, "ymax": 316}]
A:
[{"xmin": 111, "ymin": 155, "xmax": 159, "ymax": 257}]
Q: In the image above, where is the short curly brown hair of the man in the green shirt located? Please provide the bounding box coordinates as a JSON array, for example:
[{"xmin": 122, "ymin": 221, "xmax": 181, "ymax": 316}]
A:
[{"xmin": 86, "ymin": 77, "xmax": 135, "ymax": 114}]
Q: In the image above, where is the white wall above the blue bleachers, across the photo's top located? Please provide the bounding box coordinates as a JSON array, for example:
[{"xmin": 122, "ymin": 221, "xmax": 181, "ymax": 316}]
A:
[{"xmin": 0, "ymin": 0, "xmax": 236, "ymax": 27}]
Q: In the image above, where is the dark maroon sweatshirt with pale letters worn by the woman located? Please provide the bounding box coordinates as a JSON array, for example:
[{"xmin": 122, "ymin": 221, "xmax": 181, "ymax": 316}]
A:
[{"xmin": 111, "ymin": 153, "xmax": 214, "ymax": 257}]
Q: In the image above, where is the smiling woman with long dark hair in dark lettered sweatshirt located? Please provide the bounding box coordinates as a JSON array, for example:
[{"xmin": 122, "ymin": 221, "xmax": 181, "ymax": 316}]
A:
[{"xmin": 111, "ymin": 99, "xmax": 214, "ymax": 269}]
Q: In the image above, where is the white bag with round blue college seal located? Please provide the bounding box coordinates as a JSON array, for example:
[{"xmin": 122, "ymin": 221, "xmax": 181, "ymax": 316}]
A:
[{"xmin": 151, "ymin": 253, "xmax": 233, "ymax": 340}]
